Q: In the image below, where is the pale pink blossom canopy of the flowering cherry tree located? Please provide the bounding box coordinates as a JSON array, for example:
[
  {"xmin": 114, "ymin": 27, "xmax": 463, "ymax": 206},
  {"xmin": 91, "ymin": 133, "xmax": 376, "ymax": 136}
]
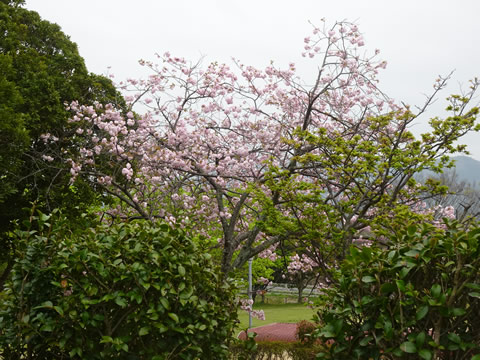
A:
[{"xmin": 44, "ymin": 22, "xmax": 432, "ymax": 271}]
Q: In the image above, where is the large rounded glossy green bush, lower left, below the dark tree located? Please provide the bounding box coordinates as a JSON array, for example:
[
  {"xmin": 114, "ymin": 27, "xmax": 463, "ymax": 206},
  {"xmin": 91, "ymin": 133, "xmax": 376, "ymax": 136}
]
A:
[{"xmin": 0, "ymin": 214, "xmax": 236, "ymax": 360}]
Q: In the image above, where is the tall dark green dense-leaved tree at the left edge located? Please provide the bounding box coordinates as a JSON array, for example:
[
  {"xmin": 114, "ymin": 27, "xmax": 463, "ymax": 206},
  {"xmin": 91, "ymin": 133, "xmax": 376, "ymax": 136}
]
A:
[{"xmin": 0, "ymin": 0, "xmax": 122, "ymax": 286}]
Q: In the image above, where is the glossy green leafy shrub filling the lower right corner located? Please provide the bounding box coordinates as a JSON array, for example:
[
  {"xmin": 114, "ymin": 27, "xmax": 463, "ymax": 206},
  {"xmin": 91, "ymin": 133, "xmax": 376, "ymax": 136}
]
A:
[{"xmin": 316, "ymin": 222, "xmax": 480, "ymax": 360}]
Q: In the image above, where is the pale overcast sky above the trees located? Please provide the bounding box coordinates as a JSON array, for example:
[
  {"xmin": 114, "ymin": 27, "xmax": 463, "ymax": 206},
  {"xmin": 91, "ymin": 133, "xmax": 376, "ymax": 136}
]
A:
[{"xmin": 26, "ymin": 0, "xmax": 480, "ymax": 160}]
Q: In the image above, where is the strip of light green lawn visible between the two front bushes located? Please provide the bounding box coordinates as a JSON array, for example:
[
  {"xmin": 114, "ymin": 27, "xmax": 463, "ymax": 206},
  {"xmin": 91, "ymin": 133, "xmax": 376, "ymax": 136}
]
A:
[{"xmin": 238, "ymin": 304, "xmax": 314, "ymax": 329}]
